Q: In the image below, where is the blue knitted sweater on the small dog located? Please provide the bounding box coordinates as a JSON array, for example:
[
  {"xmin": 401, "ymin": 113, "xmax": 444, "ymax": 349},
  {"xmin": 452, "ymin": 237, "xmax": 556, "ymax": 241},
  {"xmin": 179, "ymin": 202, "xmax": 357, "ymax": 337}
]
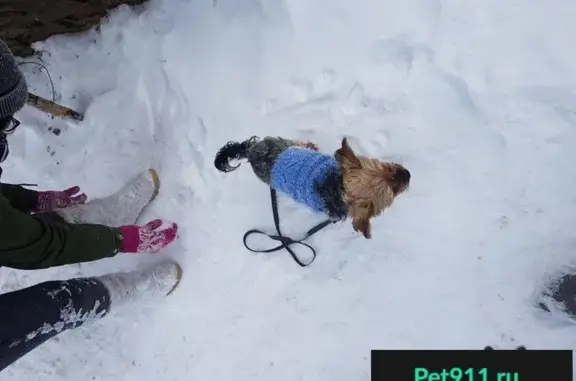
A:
[{"xmin": 270, "ymin": 147, "xmax": 338, "ymax": 212}]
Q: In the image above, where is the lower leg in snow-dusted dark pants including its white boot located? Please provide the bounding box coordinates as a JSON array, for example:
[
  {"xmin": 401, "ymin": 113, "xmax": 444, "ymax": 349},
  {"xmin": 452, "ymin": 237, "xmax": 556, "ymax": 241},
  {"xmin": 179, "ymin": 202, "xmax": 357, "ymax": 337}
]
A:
[{"xmin": 0, "ymin": 262, "xmax": 182, "ymax": 371}]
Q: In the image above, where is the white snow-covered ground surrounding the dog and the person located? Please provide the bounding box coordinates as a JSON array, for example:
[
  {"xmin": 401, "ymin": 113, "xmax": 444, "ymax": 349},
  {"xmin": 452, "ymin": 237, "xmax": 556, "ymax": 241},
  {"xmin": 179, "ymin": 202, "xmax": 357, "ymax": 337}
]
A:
[{"xmin": 0, "ymin": 0, "xmax": 576, "ymax": 381}]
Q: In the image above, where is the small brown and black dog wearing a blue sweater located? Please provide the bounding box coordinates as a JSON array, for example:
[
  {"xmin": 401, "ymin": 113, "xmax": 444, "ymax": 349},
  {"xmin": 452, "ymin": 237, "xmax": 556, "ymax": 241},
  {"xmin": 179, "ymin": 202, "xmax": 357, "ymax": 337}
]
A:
[{"xmin": 214, "ymin": 136, "xmax": 410, "ymax": 238}]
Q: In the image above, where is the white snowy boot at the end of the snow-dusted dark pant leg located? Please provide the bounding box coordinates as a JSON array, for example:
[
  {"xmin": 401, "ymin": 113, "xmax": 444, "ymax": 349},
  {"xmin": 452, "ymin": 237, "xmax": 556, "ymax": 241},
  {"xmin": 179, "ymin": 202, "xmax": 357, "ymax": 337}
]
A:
[{"xmin": 95, "ymin": 261, "xmax": 182, "ymax": 308}]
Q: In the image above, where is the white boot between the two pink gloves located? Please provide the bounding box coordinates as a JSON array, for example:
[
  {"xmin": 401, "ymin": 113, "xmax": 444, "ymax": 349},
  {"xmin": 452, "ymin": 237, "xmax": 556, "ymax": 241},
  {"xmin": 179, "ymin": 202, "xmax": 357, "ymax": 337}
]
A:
[{"xmin": 55, "ymin": 169, "xmax": 160, "ymax": 227}]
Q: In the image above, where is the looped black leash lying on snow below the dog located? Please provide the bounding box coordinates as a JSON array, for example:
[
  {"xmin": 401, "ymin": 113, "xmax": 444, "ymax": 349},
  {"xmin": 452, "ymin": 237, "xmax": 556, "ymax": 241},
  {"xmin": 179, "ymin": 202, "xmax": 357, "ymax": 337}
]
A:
[{"xmin": 242, "ymin": 188, "xmax": 336, "ymax": 267}]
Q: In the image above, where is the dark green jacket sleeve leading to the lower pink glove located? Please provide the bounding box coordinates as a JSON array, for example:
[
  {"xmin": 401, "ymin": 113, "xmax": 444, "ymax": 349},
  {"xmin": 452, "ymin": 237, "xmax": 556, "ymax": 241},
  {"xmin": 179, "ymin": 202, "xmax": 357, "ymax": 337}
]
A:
[{"xmin": 0, "ymin": 196, "xmax": 122, "ymax": 270}]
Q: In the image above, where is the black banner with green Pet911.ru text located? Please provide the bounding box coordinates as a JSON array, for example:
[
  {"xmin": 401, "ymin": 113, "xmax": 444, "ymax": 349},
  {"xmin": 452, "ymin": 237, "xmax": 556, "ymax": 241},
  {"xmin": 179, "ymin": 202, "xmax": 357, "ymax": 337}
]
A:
[{"xmin": 371, "ymin": 350, "xmax": 574, "ymax": 381}]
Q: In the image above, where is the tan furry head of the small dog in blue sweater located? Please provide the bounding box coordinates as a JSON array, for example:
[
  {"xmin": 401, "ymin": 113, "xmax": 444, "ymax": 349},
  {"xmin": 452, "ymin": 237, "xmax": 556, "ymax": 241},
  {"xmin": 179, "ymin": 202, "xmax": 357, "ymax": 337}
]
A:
[{"xmin": 334, "ymin": 138, "xmax": 410, "ymax": 238}]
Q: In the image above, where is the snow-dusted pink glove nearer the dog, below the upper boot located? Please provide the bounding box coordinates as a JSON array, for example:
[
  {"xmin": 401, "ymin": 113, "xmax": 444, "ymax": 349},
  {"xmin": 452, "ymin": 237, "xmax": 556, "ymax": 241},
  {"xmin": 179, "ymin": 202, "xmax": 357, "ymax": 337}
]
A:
[{"xmin": 120, "ymin": 220, "xmax": 178, "ymax": 253}]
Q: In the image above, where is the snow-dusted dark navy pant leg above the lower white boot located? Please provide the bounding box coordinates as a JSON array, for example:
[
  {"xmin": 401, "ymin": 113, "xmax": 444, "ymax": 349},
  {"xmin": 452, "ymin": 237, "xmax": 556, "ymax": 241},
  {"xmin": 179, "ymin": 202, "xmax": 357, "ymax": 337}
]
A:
[{"xmin": 0, "ymin": 278, "xmax": 110, "ymax": 371}]
